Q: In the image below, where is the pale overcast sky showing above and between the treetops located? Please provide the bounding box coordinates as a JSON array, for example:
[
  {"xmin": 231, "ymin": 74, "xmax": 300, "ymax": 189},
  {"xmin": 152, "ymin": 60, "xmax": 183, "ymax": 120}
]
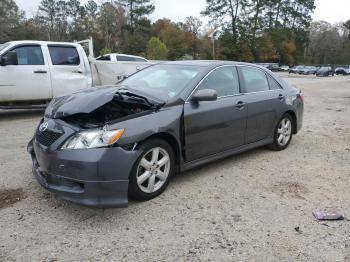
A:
[{"xmin": 15, "ymin": 0, "xmax": 350, "ymax": 23}]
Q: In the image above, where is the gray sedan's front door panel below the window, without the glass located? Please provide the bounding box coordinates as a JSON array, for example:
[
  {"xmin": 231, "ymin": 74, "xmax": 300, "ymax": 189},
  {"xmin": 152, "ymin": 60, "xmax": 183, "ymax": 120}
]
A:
[{"xmin": 184, "ymin": 96, "xmax": 247, "ymax": 162}]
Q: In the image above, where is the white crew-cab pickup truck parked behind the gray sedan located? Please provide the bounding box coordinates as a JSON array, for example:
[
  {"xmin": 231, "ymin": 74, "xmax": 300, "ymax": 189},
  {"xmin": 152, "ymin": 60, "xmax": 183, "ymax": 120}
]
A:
[{"xmin": 0, "ymin": 40, "xmax": 152, "ymax": 109}]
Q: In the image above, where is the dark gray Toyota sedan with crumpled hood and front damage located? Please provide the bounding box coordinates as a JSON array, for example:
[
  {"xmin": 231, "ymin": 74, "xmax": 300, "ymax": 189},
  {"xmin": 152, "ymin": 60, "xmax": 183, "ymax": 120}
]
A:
[{"xmin": 28, "ymin": 61, "xmax": 304, "ymax": 207}]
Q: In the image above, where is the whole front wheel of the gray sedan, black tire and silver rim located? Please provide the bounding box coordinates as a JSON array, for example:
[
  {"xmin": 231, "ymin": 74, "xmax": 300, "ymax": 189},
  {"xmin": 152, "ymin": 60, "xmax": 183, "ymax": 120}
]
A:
[{"xmin": 129, "ymin": 139, "xmax": 175, "ymax": 201}]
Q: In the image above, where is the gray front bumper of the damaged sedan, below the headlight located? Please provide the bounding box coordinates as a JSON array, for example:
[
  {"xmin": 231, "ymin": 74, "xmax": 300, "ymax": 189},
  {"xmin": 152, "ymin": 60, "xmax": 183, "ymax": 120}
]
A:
[{"xmin": 27, "ymin": 138, "xmax": 140, "ymax": 208}]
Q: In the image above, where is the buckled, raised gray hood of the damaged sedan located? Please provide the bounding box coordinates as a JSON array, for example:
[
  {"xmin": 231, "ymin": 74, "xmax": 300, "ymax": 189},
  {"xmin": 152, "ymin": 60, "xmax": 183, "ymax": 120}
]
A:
[{"xmin": 45, "ymin": 86, "xmax": 164, "ymax": 118}]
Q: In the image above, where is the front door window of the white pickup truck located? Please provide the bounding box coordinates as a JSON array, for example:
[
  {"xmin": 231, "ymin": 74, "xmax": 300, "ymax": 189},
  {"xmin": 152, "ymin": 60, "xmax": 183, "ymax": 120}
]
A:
[{"xmin": 11, "ymin": 45, "xmax": 45, "ymax": 65}]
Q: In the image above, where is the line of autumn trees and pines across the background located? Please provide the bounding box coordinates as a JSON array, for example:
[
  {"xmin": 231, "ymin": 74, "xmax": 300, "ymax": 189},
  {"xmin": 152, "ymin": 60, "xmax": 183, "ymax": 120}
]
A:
[{"xmin": 0, "ymin": 0, "xmax": 350, "ymax": 65}]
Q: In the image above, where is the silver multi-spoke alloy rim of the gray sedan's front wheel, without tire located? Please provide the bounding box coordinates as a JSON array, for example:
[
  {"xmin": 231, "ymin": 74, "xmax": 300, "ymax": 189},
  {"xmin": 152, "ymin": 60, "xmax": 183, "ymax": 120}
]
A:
[{"xmin": 137, "ymin": 147, "xmax": 171, "ymax": 194}]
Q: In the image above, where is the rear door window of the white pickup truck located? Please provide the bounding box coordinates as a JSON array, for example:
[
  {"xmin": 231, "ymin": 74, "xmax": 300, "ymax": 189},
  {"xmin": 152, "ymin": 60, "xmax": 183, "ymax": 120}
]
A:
[{"xmin": 49, "ymin": 46, "xmax": 80, "ymax": 66}]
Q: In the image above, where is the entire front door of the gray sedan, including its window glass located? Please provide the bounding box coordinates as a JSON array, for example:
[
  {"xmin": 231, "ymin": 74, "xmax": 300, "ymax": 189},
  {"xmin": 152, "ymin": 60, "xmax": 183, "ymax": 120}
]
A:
[{"xmin": 184, "ymin": 66, "xmax": 247, "ymax": 161}]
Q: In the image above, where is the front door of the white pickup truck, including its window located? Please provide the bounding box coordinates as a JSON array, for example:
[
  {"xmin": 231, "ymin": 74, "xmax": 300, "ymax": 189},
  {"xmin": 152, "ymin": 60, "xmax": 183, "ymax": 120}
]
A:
[{"xmin": 0, "ymin": 45, "xmax": 52, "ymax": 101}]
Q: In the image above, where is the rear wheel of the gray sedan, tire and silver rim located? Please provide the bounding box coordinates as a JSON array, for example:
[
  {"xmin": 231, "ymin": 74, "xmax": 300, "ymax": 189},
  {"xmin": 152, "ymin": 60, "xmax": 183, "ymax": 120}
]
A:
[{"xmin": 269, "ymin": 114, "xmax": 294, "ymax": 151}]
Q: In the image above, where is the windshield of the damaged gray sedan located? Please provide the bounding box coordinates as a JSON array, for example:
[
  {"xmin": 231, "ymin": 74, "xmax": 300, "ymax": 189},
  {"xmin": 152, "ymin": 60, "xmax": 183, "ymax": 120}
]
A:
[{"xmin": 121, "ymin": 64, "xmax": 203, "ymax": 101}]
